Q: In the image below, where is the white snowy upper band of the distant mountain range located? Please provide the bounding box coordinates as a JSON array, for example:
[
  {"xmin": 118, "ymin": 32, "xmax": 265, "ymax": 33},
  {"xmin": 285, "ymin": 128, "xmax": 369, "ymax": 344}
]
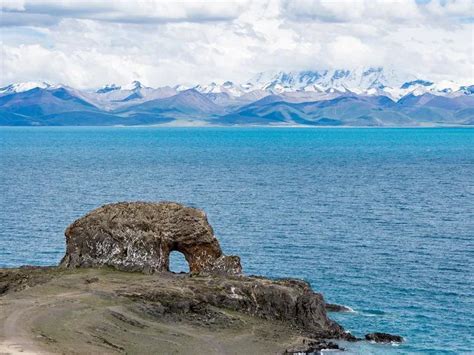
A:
[{"xmin": 0, "ymin": 67, "xmax": 474, "ymax": 109}]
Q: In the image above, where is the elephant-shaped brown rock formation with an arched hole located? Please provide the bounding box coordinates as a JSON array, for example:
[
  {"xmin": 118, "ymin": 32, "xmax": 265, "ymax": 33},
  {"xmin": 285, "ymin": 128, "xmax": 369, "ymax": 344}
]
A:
[{"xmin": 60, "ymin": 202, "xmax": 242, "ymax": 274}]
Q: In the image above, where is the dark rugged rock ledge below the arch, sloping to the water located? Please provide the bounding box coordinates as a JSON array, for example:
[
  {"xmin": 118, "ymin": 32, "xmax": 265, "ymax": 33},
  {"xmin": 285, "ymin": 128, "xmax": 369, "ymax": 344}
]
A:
[{"xmin": 118, "ymin": 275, "xmax": 353, "ymax": 340}]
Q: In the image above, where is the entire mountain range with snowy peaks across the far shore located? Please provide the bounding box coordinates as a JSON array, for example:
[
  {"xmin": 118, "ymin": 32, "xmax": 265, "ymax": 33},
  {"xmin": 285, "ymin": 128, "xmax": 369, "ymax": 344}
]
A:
[{"xmin": 0, "ymin": 67, "xmax": 474, "ymax": 126}]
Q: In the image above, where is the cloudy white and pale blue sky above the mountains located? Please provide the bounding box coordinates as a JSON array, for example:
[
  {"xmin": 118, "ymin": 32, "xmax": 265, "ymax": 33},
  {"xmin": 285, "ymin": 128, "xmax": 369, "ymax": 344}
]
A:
[{"xmin": 0, "ymin": 0, "xmax": 474, "ymax": 89}]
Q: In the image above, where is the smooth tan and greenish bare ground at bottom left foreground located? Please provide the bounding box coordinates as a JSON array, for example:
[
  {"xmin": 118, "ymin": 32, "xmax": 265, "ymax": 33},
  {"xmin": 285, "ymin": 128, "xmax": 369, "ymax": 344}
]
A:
[{"xmin": 0, "ymin": 269, "xmax": 314, "ymax": 354}]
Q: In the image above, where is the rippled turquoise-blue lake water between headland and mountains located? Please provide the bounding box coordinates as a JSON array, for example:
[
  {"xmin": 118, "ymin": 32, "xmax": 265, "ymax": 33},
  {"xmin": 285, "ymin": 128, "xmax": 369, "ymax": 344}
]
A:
[{"xmin": 0, "ymin": 128, "xmax": 474, "ymax": 354}]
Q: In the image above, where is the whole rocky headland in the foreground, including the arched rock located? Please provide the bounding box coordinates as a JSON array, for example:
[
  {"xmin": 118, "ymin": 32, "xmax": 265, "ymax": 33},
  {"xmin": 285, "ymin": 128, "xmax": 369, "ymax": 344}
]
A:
[{"xmin": 0, "ymin": 202, "xmax": 403, "ymax": 354}]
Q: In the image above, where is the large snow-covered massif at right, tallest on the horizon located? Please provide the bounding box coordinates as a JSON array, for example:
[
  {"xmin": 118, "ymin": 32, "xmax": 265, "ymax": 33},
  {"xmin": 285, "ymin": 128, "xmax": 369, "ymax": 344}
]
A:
[{"xmin": 190, "ymin": 67, "xmax": 465, "ymax": 101}]
